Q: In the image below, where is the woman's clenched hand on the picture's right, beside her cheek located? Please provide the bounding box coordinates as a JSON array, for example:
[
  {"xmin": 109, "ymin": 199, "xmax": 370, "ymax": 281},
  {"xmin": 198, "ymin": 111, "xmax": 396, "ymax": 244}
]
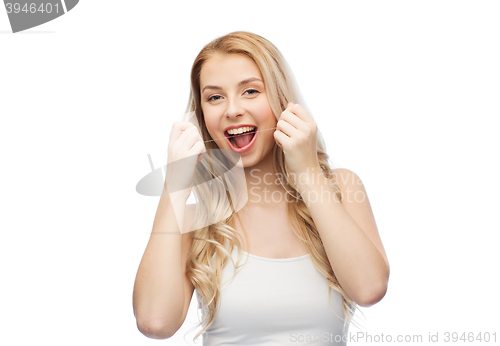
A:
[{"xmin": 274, "ymin": 102, "xmax": 320, "ymax": 177}]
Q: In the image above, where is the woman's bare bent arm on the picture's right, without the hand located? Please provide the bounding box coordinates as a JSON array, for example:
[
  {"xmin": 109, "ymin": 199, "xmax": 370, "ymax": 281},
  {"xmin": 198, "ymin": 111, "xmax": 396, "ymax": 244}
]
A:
[{"xmin": 297, "ymin": 167, "xmax": 389, "ymax": 307}]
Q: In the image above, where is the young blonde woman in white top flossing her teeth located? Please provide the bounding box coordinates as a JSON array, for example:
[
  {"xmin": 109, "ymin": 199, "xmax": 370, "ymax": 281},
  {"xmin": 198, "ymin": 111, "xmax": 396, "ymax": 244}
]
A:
[{"xmin": 133, "ymin": 31, "xmax": 389, "ymax": 346}]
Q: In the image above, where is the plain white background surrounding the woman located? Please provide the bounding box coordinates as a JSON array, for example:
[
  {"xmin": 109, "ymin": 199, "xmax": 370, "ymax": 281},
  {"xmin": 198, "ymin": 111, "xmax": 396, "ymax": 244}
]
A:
[{"xmin": 0, "ymin": 0, "xmax": 500, "ymax": 345}]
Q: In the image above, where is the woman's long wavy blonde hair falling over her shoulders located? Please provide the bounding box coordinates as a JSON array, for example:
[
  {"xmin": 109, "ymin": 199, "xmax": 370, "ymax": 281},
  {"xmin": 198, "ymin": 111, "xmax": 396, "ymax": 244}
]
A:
[{"xmin": 186, "ymin": 31, "xmax": 357, "ymax": 340}]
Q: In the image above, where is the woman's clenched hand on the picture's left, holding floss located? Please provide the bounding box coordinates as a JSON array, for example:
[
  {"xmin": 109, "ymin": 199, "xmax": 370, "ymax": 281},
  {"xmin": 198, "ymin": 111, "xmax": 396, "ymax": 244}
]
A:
[{"xmin": 165, "ymin": 122, "xmax": 207, "ymax": 199}]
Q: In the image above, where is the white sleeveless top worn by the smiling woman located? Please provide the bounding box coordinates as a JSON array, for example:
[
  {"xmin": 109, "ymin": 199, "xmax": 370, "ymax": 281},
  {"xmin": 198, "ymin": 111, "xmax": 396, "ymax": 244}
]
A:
[{"xmin": 196, "ymin": 246, "xmax": 349, "ymax": 346}]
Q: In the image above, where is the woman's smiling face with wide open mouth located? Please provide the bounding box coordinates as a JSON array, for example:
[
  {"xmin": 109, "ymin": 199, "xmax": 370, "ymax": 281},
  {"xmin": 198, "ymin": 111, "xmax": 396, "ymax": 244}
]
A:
[{"xmin": 200, "ymin": 54, "xmax": 277, "ymax": 167}]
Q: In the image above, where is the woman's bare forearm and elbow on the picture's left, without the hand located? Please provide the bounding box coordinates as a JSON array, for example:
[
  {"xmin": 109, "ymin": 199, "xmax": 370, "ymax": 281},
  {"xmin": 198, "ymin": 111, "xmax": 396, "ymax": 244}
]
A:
[{"xmin": 133, "ymin": 186, "xmax": 194, "ymax": 339}]
